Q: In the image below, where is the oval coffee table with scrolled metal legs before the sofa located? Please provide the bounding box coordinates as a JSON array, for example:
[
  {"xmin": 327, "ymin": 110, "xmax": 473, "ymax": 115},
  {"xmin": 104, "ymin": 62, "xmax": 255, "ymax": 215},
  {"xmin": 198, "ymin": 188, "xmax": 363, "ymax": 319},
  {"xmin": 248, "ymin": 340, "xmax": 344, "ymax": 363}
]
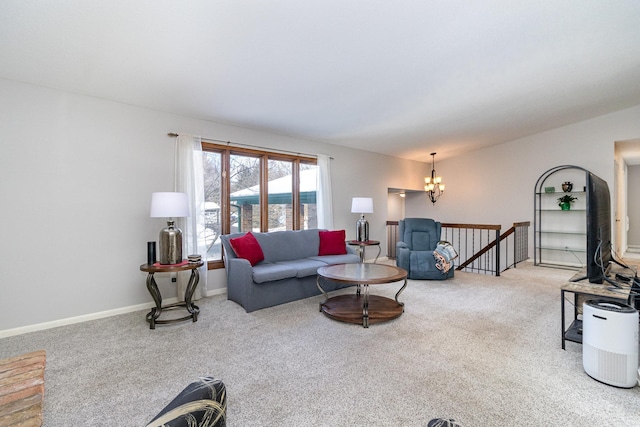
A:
[{"xmin": 316, "ymin": 263, "xmax": 407, "ymax": 328}]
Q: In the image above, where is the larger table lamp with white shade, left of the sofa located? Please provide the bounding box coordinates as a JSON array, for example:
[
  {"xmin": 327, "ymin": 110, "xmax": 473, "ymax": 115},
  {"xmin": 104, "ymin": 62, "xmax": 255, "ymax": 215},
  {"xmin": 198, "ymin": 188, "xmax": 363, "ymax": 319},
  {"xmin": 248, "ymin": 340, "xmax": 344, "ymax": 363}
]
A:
[{"xmin": 150, "ymin": 192, "xmax": 189, "ymax": 264}]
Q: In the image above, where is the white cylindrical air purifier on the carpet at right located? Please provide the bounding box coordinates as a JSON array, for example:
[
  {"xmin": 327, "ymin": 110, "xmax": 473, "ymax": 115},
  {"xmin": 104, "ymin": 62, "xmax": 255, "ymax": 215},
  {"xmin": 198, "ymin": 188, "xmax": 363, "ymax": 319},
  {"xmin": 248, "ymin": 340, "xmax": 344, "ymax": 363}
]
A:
[{"xmin": 582, "ymin": 300, "xmax": 638, "ymax": 388}]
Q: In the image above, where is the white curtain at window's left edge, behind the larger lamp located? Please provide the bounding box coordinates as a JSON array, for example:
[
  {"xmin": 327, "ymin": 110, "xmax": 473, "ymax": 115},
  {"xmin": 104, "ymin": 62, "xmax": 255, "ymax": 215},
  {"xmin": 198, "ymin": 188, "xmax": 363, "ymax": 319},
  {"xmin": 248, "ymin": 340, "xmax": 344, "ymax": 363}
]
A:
[{"xmin": 175, "ymin": 135, "xmax": 207, "ymax": 299}]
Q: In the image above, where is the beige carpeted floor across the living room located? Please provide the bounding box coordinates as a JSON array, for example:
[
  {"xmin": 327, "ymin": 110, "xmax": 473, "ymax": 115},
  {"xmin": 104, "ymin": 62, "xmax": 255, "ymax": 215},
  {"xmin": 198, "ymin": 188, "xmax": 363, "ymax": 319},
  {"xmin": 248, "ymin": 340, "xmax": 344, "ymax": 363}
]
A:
[{"xmin": 0, "ymin": 263, "xmax": 640, "ymax": 427}]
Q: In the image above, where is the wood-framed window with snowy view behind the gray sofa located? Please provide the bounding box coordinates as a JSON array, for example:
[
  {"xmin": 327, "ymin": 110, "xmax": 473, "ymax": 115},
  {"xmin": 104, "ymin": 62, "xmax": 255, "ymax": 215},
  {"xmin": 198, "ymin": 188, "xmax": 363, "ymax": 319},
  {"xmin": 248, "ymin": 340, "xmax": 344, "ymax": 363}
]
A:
[{"xmin": 202, "ymin": 142, "xmax": 318, "ymax": 268}]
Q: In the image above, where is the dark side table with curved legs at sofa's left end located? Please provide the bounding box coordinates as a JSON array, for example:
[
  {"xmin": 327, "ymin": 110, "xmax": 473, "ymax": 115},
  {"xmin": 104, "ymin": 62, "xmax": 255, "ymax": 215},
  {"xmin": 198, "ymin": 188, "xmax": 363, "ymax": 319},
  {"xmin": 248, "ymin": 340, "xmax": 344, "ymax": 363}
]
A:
[{"xmin": 140, "ymin": 261, "xmax": 204, "ymax": 329}]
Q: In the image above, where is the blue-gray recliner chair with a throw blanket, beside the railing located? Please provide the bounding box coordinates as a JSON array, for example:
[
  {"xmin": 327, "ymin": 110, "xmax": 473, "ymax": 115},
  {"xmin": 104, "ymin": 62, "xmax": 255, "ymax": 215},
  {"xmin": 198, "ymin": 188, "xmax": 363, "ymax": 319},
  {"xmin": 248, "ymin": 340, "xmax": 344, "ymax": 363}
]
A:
[{"xmin": 396, "ymin": 218, "xmax": 454, "ymax": 280}]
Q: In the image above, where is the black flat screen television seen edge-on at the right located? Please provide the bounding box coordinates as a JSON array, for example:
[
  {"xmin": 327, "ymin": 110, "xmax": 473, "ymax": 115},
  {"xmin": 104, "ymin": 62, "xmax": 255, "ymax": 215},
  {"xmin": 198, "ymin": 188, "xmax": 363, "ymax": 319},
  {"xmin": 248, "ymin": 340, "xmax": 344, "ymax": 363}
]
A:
[{"xmin": 586, "ymin": 172, "xmax": 616, "ymax": 283}]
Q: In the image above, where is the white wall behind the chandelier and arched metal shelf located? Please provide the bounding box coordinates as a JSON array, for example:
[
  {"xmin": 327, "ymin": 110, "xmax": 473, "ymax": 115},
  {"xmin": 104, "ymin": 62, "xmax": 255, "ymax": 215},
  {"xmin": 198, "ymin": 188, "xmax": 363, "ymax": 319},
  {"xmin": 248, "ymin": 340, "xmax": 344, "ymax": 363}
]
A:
[{"xmin": 406, "ymin": 106, "xmax": 640, "ymax": 256}]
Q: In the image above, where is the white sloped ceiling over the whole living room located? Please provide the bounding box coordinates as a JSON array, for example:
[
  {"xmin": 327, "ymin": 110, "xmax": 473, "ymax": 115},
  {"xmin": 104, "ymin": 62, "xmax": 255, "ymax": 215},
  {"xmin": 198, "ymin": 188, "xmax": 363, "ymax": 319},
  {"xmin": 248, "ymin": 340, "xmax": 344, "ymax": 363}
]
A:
[{"xmin": 0, "ymin": 0, "xmax": 640, "ymax": 162}]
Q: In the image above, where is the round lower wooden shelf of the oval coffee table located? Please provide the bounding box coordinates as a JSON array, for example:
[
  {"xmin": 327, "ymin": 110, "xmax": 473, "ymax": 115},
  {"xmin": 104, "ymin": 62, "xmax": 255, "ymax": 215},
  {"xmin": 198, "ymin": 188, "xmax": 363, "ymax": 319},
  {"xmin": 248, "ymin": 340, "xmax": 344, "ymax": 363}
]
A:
[{"xmin": 320, "ymin": 294, "xmax": 404, "ymax": 328}]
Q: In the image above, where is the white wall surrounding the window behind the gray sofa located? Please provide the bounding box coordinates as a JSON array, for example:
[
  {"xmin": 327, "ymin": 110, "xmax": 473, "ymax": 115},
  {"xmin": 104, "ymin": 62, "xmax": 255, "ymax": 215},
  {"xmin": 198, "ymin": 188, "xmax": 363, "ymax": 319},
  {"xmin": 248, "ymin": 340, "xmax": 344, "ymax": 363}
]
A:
[{"xmin": 0, "ymin": 79, "xmax": 425, "ymax": 337}]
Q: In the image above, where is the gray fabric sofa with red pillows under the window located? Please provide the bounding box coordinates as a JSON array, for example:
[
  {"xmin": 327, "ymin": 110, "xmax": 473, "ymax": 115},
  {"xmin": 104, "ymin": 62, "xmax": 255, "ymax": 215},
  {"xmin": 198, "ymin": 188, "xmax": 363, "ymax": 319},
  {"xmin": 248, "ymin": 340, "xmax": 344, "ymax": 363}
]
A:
[{"xmin": 220, "ymin": 229, "xmax": 360, "ymax": 313}]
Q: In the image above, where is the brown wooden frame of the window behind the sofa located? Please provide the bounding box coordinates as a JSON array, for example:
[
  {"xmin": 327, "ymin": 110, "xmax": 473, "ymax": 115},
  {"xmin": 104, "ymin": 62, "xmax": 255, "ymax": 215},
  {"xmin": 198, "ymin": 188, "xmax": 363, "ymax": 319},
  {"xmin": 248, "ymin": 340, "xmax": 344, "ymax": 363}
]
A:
[{"xmin": 202, "ymin": 144, "xmax": 318, "ymax": 270}]
